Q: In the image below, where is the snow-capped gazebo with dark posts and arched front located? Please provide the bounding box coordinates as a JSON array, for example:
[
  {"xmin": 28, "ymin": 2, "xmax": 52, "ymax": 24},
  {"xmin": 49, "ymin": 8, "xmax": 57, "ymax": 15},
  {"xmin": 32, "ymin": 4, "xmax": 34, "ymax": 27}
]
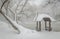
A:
[{"xmin": 34, "ymin": 14, "xmax": 56, "ymax": 31}]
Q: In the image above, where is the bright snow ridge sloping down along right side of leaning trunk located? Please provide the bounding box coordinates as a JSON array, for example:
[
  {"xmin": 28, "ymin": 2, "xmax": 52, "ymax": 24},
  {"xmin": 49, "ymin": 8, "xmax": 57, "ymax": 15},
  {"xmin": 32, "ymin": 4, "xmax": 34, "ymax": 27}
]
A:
[{"xmin": 7, "ymin": 16, "xmax": 36, "ymax": 33}]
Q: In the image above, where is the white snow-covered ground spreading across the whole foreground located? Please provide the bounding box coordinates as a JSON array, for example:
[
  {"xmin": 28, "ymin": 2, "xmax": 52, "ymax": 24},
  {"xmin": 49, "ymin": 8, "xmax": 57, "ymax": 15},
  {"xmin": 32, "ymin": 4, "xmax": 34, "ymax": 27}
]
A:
[{"xmin": 0, "ymin": 14, "xmax": 60, "ymax": 39}]
